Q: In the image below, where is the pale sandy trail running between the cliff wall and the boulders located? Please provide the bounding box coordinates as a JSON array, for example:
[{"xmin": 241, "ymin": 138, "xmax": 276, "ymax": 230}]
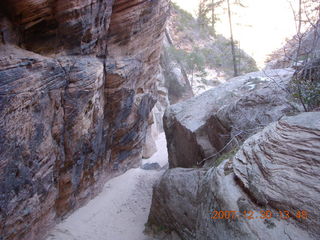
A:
[{"xmin": 47, "ymin": 134, "xmax": 168, "ymax": 240}]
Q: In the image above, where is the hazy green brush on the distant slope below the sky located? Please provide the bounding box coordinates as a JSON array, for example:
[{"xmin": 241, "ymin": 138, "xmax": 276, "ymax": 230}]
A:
[{"xmin": 168, "ymin": 1, "xmax": 258, "ymax": 78}]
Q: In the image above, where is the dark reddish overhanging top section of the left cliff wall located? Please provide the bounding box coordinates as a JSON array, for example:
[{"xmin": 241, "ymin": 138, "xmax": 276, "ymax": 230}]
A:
[{"xmin": 1, "ymin": 0, "xmax": 114, "ymax": 55}]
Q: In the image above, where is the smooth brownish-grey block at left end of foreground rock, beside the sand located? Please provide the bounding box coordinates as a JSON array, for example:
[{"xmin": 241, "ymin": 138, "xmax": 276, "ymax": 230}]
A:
[{"xmin": 148, "ymin": 168, "xmax": 203, "ymax": 239}]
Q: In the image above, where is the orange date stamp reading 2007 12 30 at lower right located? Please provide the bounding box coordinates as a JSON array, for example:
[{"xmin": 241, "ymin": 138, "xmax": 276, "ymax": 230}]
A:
[{"xmin": 210, "ymin": 210, "xmax": 309, "ymax": 220}]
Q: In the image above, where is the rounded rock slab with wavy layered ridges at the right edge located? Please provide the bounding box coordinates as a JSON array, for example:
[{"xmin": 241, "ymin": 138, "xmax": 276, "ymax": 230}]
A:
[{"xmin": 233, "ymin": 112, "xmax": 320, "ymax": 234}]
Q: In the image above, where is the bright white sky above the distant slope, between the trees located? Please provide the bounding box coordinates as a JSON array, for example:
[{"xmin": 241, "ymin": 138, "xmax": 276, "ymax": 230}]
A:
[{"xmin": 173, "ymin": 0, "xmax": 296, "ymax": 68}]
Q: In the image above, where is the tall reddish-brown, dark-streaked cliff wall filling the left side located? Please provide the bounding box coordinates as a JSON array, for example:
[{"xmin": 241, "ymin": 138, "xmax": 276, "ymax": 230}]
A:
[{"xmin": 0, "ymin": 0, "xmax": 168, "ymax": 240}]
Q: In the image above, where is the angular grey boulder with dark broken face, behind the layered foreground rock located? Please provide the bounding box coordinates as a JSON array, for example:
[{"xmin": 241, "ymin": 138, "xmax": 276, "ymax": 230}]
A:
[{"xmin": 164, "ymin": 69, "xmax": 298, "ymax": 168}]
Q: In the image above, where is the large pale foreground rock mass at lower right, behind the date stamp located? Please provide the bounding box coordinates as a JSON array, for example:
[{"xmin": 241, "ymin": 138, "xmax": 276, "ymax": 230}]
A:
[{"xmin": 149, "ymin": 112, "xmax": 320, "ymax": 240}]
